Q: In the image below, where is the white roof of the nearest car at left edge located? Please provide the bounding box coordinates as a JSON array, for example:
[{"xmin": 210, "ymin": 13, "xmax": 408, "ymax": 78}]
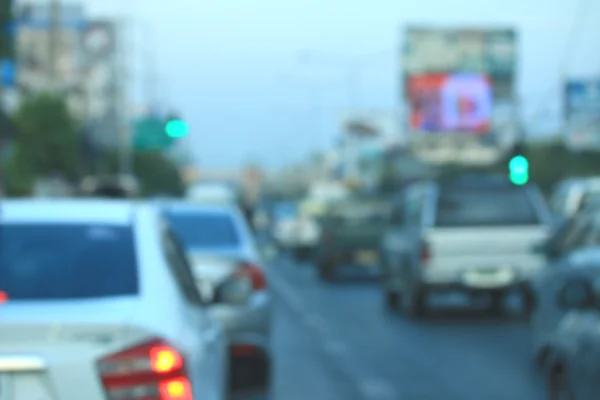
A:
[{"xmin": 0, "ymin": 199, "xmax": 139, "ymax": 225}]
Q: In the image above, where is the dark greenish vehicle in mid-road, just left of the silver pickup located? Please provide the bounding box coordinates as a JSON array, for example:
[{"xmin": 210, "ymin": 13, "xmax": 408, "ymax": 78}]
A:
[{"xmin": 315, "ymin": 199, "xmax": 389, "ymax": 280}]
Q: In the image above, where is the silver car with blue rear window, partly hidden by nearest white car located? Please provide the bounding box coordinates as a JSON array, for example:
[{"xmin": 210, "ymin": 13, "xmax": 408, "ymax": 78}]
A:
[{"xmin": 163, "ymin": 202, "xmax": 271, "ymax": 396}]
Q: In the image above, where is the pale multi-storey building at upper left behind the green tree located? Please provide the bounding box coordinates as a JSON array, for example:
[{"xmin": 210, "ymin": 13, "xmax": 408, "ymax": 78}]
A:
[{"xmin": 16, "ymin": 4, "xmax": 126, "ymax": 148}]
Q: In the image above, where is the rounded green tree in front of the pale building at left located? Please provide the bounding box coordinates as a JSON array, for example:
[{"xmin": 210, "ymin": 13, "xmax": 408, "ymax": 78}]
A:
[{"xmin": 13, "ymin": 93, "xmax": 79, "ymax": 181}]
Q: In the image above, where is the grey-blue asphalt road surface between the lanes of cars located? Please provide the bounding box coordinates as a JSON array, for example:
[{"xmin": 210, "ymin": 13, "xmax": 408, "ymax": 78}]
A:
[{"xmin": 269, "ymin": 255, "xmax": 545, "ymax": 400}]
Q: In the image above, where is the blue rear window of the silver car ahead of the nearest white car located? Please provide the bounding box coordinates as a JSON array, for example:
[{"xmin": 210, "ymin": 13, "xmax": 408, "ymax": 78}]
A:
[{"xmin": 166, "ymin": 211, "xmax": 241, "ymax": 249}]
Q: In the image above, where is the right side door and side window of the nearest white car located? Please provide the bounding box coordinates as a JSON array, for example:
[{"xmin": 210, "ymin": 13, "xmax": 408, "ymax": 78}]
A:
[{"xmin": 163, "ymin": 229, "xmax": 229, "ymax": 400}]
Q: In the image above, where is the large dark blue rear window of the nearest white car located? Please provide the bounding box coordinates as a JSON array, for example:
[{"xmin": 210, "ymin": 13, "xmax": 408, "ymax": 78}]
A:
[{"xmin": 0, "ymin": 224, "xmax": 139, "ymax": 300}]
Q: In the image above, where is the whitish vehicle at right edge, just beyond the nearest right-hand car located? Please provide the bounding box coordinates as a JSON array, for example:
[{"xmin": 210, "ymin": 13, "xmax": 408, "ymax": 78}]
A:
[{"xmin": 550, "ymin": 178, "xmax": 600, "ymax": 219}]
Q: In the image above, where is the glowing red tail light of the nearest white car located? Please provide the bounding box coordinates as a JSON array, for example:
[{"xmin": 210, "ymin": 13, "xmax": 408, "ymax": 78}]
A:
[{"xmin": 98, "ymin": 339, "xmax": 193, "ymax": 400}]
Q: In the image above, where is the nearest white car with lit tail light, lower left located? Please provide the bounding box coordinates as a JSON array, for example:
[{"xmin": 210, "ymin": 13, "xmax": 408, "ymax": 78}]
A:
[{"xmin": 0, "ymin": 200, "xmax": 229, "ymax": 400}]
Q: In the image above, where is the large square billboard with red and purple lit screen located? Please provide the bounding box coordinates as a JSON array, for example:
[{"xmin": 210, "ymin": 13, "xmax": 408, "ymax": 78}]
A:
[{"xmin": 402, "ymin": 27, "xmax": 518, "ymax": 137}]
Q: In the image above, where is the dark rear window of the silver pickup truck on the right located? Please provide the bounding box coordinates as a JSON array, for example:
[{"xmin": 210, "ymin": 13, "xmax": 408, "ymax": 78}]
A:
[{"xmin": 436, "ymin": 188, "xmax": 540, "ymax": 227}]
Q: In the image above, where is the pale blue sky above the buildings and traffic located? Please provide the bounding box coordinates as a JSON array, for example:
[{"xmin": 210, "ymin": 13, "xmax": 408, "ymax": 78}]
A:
[{"xmin": 76, "ymin": 0, "xmax": 600, "ymax": 167}]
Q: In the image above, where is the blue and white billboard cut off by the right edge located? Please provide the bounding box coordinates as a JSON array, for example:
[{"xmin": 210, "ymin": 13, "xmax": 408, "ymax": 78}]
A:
[{"xmin": 564, "ymin": 79, "xmax": 600, "ymax": 150}]
